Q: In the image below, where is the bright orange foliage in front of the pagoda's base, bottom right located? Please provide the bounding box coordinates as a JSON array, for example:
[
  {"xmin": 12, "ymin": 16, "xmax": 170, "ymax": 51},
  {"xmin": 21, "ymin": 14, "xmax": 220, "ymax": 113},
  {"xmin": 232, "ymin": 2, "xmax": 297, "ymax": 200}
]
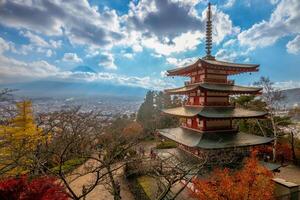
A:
[{"xmin": 192, "ymin": 153, "xmax": 274, "ymax": 200}]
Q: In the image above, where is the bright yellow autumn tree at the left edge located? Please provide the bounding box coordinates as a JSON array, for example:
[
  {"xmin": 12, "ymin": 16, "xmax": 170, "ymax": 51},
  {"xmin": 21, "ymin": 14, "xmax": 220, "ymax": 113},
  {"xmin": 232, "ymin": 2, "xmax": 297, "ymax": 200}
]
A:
[{"xmin": 0, "ymin": 101, "xmax": 48, "ymax": 175}]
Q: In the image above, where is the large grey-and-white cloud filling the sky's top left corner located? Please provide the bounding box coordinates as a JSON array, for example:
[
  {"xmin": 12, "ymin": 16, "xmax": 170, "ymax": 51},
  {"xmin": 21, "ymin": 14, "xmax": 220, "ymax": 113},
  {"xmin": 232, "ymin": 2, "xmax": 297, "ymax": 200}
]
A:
[{"xmin": 0, "ymin": 0, "xmax": 124, "ymax": 47}]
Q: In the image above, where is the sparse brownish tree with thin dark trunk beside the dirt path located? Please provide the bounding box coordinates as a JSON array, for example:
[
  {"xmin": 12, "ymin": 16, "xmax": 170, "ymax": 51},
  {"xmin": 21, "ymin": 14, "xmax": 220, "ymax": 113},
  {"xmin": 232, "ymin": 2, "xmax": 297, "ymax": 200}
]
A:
[{"xmin": 93, "ymin": 119, "xmax": 143, "ymax": 200}]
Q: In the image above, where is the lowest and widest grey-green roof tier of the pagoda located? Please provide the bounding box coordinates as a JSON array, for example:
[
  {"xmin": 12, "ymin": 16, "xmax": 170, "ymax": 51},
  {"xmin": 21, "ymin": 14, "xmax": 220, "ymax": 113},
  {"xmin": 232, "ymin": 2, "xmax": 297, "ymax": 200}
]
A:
[{"xmin": 158, "ymin": 127, "xmax": 273, "ymax": 149}]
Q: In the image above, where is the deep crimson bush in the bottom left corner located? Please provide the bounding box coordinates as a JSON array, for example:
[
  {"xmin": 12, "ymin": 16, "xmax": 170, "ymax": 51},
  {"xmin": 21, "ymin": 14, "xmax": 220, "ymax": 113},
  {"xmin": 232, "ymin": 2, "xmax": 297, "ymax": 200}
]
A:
[{"xmin": 0, "ymin": 175, "xmax": 68, "ymax": 200}]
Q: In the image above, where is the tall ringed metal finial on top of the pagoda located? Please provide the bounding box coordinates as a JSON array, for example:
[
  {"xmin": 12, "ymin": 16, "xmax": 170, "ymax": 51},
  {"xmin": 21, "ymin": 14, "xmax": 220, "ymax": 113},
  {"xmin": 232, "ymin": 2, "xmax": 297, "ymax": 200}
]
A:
[{"xmin": 204, "ymin": 2, "xmax": 215, "ymax": 60}]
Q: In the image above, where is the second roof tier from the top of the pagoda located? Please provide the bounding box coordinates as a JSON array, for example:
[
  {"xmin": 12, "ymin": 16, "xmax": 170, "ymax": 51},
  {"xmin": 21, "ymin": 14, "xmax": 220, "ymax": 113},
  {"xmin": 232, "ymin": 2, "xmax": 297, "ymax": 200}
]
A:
[{"xmin": 165, "ymin": 83, "xmax": 262, "ymax": 94}]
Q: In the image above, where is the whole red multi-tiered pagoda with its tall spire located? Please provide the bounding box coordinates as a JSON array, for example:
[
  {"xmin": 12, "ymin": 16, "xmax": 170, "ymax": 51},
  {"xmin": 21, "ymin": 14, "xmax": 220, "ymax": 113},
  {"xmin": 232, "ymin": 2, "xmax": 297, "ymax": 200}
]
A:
[{"xmin": 158, "ymin": 4, "xmax": 273, "ymax": 165}]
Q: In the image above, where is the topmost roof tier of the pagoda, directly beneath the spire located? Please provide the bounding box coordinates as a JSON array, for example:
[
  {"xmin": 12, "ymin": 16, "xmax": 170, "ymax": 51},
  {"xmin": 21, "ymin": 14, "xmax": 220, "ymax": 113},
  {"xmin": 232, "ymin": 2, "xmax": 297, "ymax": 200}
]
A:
[{"xmin": 167, "ymin": 58, "xmax": 259, "ymax": 76}]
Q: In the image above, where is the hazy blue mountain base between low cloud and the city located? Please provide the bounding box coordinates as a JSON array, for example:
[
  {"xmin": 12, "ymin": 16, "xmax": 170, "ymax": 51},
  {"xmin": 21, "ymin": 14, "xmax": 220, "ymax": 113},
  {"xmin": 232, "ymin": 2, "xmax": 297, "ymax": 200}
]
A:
[{"xmin": 0, "ymin": 81, "xmax": 147, "ymax": 98}]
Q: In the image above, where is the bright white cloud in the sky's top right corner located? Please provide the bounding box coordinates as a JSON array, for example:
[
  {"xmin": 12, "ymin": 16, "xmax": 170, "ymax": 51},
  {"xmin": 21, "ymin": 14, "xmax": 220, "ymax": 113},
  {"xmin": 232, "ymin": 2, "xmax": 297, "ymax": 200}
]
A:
[{"xmin": 238, "ymin": 0, "xmax": 300, "ymax": 50}]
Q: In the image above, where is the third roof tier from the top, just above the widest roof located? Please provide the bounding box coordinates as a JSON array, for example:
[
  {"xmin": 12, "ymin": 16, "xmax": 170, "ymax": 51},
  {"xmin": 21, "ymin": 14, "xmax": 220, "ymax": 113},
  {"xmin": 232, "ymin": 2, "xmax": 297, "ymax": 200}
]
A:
[{"xmin": 162, "ymin": 106, "xmax": 267, "ymax": 119}]
